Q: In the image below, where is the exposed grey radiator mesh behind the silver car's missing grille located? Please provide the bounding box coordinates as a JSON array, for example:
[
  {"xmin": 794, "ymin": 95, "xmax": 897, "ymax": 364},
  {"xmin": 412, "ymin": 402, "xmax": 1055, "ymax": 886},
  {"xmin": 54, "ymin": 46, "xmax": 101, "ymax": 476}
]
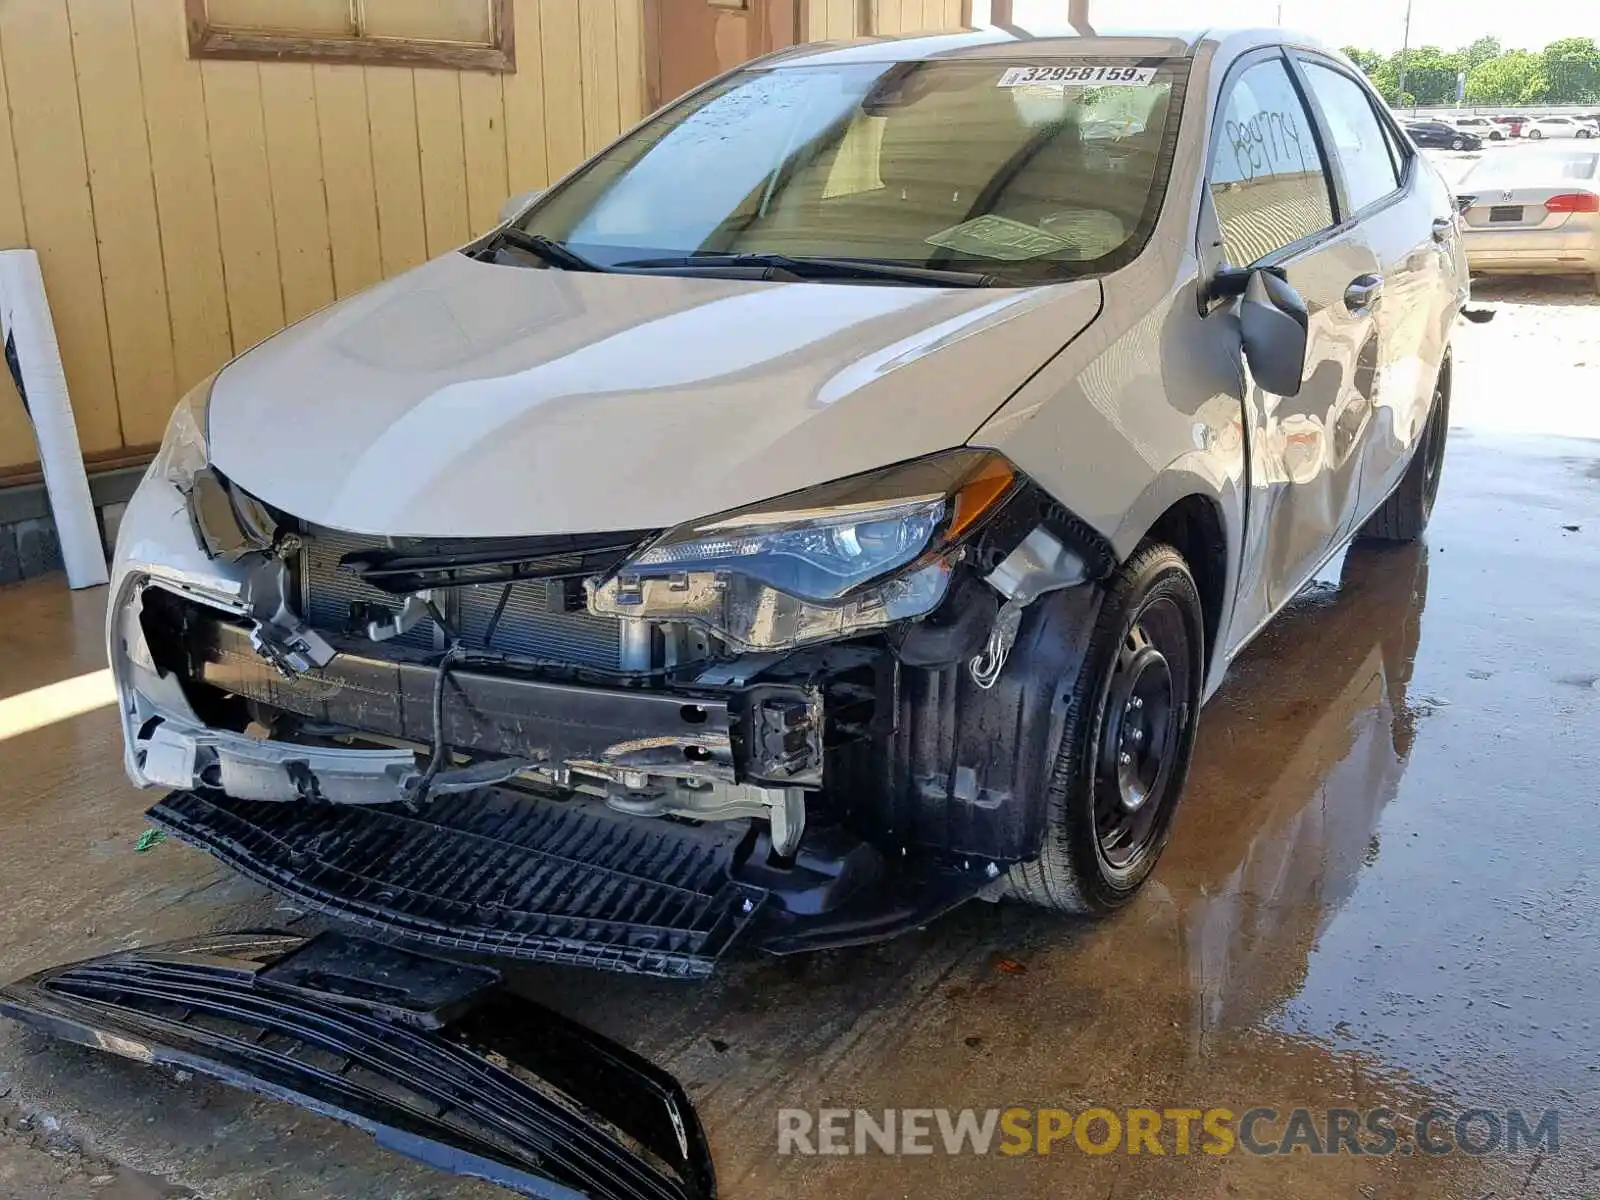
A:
[{"xmin": 299, "ymin": 528, "xmax": 621, "ymax": 670}]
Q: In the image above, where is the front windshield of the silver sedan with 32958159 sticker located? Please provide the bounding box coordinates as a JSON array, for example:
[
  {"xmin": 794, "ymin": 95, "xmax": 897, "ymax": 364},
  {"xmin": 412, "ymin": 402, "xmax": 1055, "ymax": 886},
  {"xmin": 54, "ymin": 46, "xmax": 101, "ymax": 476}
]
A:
[{"xmin": 518, "ymin": 59, "xmax": 1189, "ymax": 285}]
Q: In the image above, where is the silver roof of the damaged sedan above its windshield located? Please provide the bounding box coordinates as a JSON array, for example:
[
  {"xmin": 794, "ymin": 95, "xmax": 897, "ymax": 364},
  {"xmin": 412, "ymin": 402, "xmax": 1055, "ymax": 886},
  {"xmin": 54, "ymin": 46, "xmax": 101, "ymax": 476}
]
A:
[{"xmin": 765, "ymin": 26, "xmax": 1322, "ymax": 64}]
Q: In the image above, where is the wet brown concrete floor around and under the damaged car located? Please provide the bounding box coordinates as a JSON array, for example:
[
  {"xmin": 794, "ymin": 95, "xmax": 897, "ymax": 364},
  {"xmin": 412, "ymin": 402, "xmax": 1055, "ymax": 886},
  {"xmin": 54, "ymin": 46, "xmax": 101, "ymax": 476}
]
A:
[{"xmin": 0, "ymin": 282, "xmax": 1600, "ymax": 1200}]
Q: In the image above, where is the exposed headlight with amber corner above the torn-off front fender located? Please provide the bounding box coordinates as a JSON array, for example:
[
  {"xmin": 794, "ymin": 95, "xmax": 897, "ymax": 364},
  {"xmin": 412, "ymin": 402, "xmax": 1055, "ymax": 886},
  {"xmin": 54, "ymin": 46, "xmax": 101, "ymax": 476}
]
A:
[{"xmin": 589, "ymin": 450, "xmax": 1019, "ymax": 650}]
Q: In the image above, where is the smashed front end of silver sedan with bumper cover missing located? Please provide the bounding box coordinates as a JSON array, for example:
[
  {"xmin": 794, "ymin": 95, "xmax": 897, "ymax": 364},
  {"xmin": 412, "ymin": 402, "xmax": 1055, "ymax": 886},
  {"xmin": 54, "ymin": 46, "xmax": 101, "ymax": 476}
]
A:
[{"xmin": 109, "ymin": 385, "xmax": 1112, "ymax": 978}]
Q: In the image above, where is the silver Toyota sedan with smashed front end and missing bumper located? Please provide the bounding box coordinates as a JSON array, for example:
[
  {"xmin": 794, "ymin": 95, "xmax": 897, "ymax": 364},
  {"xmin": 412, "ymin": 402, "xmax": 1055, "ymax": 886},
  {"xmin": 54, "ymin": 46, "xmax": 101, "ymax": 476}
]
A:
[{"xmin": 109, "ymin": 30, "xmax": 1467, "ymax": 976}]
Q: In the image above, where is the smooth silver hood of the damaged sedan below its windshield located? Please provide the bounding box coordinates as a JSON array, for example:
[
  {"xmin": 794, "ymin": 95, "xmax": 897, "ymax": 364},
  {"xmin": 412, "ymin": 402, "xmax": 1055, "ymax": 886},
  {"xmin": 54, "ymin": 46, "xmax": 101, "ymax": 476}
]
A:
[{"xmin": 210, "ymin": 254, "xmax": 1101, "ymax": 538}]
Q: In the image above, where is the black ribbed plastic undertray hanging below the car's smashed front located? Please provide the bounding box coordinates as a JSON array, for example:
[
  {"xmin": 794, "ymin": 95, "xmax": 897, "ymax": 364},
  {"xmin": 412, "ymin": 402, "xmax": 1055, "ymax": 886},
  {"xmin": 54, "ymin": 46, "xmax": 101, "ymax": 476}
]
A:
[{"xmin": 149, "ymin": 789, "xmax": 766, "ymax": 978}]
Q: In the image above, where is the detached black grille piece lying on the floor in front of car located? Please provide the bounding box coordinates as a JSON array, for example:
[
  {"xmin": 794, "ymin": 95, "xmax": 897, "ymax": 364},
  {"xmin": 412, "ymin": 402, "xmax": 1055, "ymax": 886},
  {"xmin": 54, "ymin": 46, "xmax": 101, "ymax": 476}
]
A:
[{"xmin": 0, "ymin": 933, "xmax": 715, "ymax": 1200}]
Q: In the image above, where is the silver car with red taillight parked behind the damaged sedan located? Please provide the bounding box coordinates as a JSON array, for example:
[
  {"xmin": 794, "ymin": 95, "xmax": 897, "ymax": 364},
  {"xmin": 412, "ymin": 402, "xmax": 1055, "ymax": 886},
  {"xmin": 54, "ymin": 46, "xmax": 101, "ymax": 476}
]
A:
[{"xmin": 1456, "ymin": 146, "xmax": 1600, "ymax": 291}]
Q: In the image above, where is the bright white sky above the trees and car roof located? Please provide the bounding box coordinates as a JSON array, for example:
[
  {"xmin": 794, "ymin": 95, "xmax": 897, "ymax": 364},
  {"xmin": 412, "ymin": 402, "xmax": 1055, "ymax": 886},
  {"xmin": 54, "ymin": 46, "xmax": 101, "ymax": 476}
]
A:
[{"xmin": 973, "ymin": 0, "xmax": 1600, "ymax": 53}]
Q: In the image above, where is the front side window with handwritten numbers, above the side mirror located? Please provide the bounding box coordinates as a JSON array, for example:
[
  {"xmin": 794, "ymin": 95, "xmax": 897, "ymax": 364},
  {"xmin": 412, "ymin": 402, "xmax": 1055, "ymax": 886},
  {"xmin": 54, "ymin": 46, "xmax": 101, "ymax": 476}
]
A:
[{"xmin": 1210, "ymin": 58, "xmax": 1333, "ymax": 267}]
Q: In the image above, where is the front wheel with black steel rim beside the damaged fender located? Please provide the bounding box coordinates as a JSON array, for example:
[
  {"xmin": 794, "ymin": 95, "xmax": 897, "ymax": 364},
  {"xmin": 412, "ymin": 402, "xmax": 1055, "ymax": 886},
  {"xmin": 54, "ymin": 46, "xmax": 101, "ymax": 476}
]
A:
[{"xmin": 1006, "ymin": 544, "xmax": 1205, "ymax": 915}]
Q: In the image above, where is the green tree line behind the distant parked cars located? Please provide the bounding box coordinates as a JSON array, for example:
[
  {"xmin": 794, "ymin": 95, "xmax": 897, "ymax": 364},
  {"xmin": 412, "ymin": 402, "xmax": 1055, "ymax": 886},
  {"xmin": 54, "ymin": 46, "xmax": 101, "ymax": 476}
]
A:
[{"xmin": 1344, "ymin": 37, "xmax": 1600, "ymax": 109}]
